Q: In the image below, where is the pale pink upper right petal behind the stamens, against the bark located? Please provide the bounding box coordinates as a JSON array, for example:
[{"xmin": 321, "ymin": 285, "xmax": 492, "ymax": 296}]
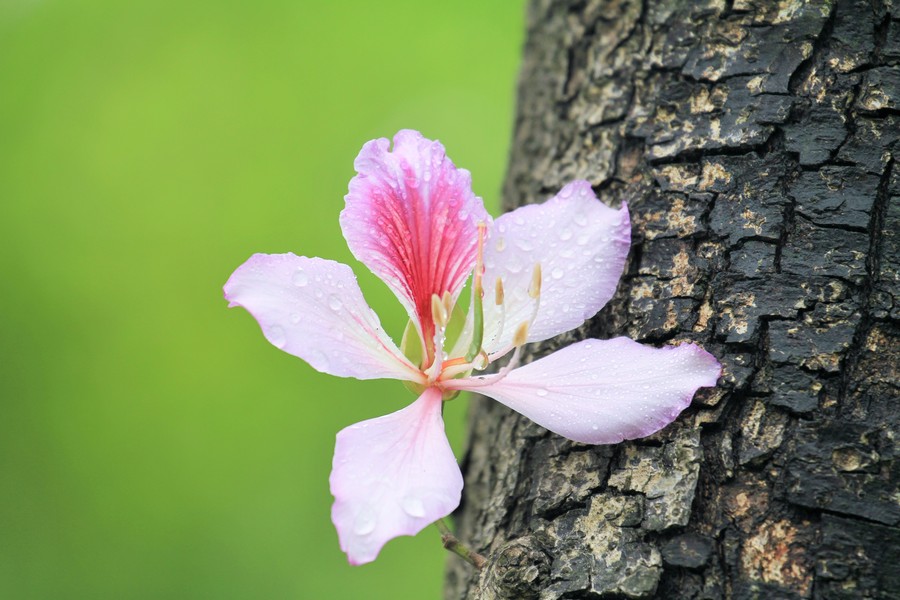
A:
[{"xmin": 484, "ymin": 181, "xmax": 631, "ymax": 353}]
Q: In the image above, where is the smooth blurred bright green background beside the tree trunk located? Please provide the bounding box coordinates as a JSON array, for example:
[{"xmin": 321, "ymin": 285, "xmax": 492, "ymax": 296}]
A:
[{"xmin": 0, "ymin": 0, "xmax": 524, "ymax": 599}]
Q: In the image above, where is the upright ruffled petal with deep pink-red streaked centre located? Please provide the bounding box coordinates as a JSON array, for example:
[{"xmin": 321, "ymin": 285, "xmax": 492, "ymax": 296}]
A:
[{"xmin": 341, "ymin": 130, "xmax": 490, "ymax": 350}]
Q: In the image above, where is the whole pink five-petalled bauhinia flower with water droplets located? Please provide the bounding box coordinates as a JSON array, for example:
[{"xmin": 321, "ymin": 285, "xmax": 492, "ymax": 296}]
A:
[{"xmin": 225, "ymin": 131, "xmax": 720, "ymax": 564}]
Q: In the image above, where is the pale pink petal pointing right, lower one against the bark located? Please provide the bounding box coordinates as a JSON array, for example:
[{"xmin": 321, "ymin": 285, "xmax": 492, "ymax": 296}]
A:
[{"xmin": 445, "ymin": 337, "xmax": 721, "ymax": 444}]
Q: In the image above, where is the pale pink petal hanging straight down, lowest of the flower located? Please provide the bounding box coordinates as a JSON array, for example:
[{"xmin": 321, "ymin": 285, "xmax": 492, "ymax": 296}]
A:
[{"xmin": 330, "ymin": 388, "xmax": 463, "ymax": 565}]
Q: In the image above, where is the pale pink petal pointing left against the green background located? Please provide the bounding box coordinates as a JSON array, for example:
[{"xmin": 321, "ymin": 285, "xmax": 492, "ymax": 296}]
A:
[{"xmin": 225, "ymin": 254, "xmax": 423, "ymax": 381}]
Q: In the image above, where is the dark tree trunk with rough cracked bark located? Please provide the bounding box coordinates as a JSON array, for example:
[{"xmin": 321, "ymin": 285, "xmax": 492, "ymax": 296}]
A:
[{"xmin": 446, "ymin": 0, "xmax": 900, "ymax": 600}]
